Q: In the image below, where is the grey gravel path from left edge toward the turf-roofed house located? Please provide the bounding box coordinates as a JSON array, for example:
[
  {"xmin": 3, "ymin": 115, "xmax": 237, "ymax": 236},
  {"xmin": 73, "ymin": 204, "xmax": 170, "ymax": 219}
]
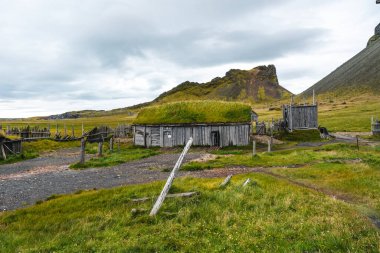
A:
[{"xmin": 0, "ymin": 149, "xmax": 211, "ymax": 211}]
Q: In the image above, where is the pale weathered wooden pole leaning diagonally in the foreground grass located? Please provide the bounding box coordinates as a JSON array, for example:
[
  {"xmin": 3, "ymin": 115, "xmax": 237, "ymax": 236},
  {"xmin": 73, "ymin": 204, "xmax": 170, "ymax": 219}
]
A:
[{"xmin": 149, "ymin": 137, "xmax": 193, "ymax": 216}]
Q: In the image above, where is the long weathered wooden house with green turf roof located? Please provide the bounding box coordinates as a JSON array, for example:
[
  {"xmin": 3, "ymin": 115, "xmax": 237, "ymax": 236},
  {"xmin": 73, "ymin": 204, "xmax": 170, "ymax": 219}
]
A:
[{"xmin": 133, "ymin": 101, "xmax": 252, "ymax": 147}]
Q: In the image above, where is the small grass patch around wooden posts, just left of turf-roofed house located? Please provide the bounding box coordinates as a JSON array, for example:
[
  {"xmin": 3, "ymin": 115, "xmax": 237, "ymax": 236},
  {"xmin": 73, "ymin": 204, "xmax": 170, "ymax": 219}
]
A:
[{"xmin": 70, "ymin": 144, "xmax": 160, "ymax": 169}]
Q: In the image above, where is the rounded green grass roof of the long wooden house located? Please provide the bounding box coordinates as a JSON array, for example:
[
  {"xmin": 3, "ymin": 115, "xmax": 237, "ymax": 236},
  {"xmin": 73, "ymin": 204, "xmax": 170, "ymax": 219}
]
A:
[{"xmin": 133, "ymin": 101, "xmax": 252, "ymax": 124}]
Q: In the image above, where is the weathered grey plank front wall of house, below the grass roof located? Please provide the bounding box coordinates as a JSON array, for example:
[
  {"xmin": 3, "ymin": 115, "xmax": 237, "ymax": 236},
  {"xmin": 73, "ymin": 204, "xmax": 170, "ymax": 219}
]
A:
[{"xmin": 134, "ymin": 123, "xmax": 251, "ymax": 147}]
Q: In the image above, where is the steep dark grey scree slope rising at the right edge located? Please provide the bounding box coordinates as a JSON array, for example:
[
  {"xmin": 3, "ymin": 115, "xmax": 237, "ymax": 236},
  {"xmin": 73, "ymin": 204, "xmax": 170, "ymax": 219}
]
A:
[{"xmin": 301, "ymin": 35, "xmax": 380, "ymax": 97}]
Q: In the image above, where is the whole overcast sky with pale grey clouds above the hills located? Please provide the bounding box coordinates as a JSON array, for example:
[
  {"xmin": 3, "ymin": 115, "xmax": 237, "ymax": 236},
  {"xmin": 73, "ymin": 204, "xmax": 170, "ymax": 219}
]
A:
[{"xmin": 0, "ymin": 0, "xmax": 380, "ymax": 118}]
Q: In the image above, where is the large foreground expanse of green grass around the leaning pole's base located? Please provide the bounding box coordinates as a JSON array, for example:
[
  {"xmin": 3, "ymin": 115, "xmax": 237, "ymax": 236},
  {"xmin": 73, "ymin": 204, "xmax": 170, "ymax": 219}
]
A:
[{"xmin": 0, "ymin": 174, "xmax": 380, "ymax": 253}]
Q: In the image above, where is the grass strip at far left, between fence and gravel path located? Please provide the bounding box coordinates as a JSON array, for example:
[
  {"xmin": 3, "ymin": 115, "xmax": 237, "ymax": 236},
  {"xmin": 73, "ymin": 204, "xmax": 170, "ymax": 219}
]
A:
[{"xmin": 0, "ymin": 139, "xmax": 80, "ymax": 165}]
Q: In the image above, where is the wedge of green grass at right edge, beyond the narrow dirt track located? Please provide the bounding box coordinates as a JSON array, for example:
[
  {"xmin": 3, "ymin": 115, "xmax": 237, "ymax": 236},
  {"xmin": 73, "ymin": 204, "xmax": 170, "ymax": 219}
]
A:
[{"xmin": 273, "ymin": 145, "xmax": 380, "ymax": 212}]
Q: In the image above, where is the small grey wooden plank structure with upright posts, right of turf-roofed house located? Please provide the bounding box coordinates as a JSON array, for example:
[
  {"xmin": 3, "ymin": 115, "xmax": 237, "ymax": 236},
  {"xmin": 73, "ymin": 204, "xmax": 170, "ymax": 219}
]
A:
[{"xmin": 282, "ymin": 91, "xmax": 318, "ymax": 132}]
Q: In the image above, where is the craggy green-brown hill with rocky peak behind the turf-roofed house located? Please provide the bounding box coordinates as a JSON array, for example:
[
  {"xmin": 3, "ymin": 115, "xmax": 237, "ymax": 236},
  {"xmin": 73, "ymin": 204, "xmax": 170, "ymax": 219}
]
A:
[{"xmin": 152, "ymin": 65, "xmax": 291, "ymax": 103}]
